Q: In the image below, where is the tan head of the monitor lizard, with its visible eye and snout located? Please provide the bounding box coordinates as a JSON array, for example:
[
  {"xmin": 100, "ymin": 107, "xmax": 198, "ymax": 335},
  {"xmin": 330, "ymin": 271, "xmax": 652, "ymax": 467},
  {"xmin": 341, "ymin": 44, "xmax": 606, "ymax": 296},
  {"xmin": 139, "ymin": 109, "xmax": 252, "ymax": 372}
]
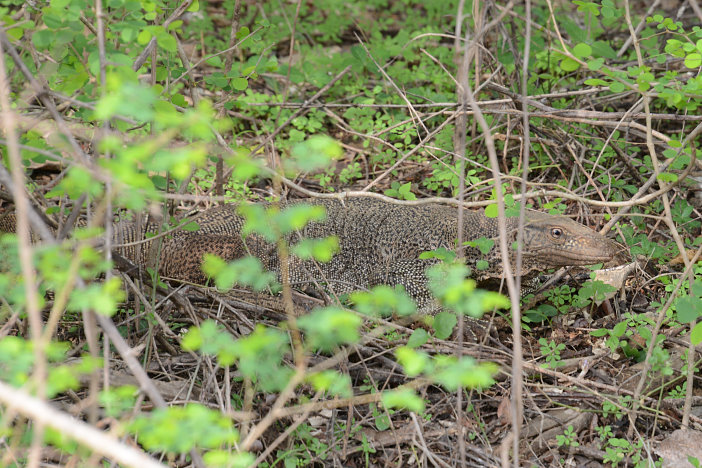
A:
[{"xmin": 514, "ymin": 212, "xmax": 619, "ymax": 267}]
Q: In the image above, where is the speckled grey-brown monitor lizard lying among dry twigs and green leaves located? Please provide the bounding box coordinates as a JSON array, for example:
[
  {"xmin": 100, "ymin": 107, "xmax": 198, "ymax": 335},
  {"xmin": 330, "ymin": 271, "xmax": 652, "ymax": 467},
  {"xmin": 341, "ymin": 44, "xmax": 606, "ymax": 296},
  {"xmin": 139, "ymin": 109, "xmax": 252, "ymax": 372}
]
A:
[{"xmin": 0, "ymin": 197, "xmax": 620, "ymax": 304}]
